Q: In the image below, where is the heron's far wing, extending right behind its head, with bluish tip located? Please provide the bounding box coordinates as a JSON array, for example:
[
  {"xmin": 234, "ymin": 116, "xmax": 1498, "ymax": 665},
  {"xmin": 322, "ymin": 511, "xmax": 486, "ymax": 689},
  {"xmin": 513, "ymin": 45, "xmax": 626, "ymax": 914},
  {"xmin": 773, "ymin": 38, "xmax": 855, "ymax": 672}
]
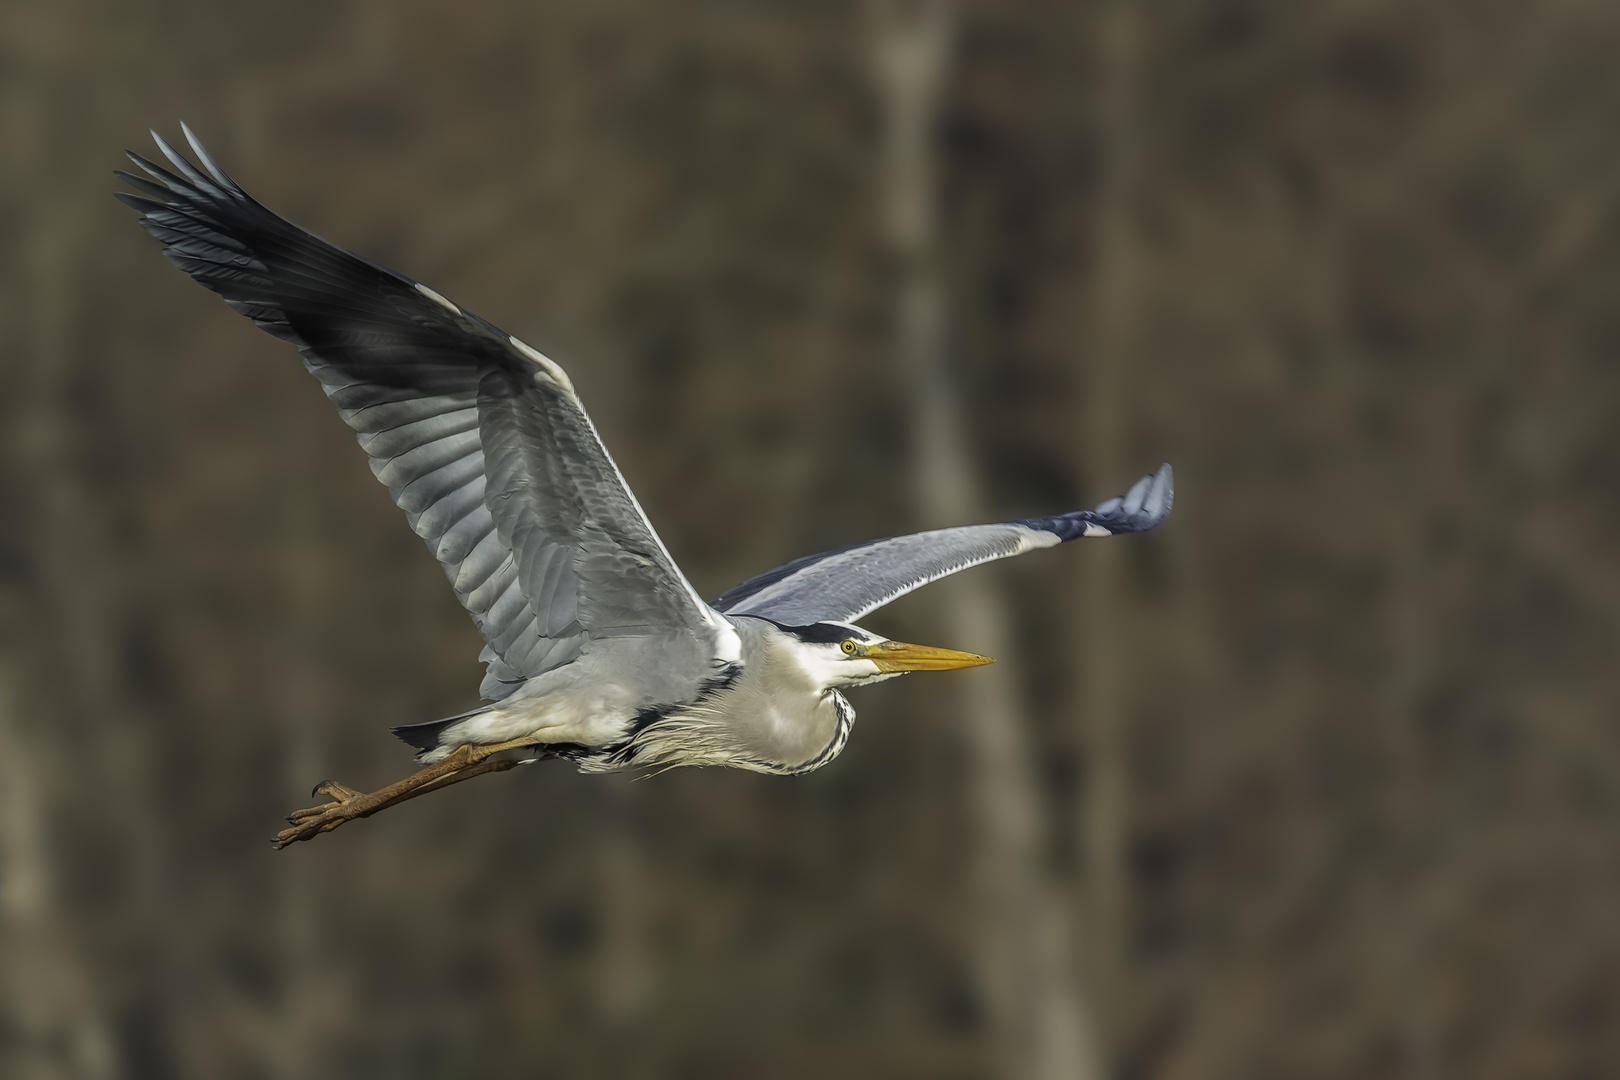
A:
[{"xmin": 714, "ymin": 465, "xmax": 1175, "ymax": 627}]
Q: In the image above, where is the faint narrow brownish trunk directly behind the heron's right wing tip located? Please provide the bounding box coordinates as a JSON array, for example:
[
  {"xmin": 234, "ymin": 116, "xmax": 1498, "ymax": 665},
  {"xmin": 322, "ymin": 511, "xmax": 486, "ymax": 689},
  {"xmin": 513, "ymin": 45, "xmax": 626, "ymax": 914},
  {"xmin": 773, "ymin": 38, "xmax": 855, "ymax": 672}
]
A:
[{"xmin": 1076, "ymin": 0, "xmax": 1142, "ymax": 1057}]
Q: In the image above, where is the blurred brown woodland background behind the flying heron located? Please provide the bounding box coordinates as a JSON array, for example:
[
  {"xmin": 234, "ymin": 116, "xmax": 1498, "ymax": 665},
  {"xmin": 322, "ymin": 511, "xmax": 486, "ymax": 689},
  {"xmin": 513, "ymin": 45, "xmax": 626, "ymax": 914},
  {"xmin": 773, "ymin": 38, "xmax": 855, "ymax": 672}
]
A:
[{"xmin": 0, "ymin": 0, "xmax": 1620, "ymax": 1080}]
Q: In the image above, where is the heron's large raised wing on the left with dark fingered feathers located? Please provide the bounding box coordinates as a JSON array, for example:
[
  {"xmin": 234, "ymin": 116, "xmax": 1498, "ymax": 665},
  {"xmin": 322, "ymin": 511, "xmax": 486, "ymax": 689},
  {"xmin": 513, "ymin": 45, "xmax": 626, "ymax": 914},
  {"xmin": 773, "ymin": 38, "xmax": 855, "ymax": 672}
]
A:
[{"xmin": 118, "ymin": 130, "xmax": 721, "ymax": 699}]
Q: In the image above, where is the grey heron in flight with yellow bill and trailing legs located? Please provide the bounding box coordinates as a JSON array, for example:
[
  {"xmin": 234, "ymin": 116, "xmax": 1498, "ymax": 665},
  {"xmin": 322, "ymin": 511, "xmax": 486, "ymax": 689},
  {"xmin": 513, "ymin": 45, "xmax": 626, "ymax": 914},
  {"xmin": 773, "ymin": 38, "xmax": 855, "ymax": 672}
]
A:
[{"xmin": 115, "ymin": 125, "xmax": 1173, "ymax": 848}]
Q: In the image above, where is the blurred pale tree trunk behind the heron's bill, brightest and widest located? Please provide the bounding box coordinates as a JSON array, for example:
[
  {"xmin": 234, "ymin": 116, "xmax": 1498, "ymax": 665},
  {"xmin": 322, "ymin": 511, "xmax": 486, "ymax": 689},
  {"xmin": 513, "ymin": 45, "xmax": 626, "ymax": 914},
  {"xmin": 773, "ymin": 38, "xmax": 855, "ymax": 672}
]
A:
[{"xmin": 872, "ymin": 0, "xmax": 1098, "ymax": 1080}]
